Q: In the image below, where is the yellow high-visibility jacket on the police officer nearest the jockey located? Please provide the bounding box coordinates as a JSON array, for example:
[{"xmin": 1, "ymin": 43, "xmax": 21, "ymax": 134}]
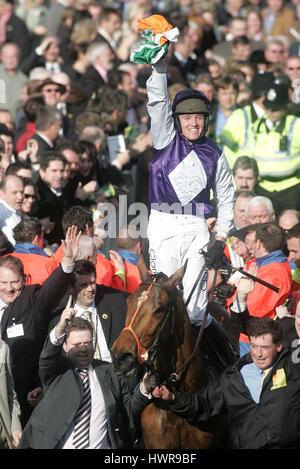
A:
[{"xmin": 217, "ymin": 104, "xmax": 258, "ymax": 169}]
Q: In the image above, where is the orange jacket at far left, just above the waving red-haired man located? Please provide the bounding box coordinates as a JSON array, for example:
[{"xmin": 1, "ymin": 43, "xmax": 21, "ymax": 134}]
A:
[{"xmin": 9, "ymin": 252, "xmax": 59, "ymax": 285}]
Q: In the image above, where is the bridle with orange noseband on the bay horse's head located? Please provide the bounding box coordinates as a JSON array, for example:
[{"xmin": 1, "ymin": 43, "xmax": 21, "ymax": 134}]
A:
[{"xmin": 123, "ymin": 278, "xmax": 175, "ymax": 369}]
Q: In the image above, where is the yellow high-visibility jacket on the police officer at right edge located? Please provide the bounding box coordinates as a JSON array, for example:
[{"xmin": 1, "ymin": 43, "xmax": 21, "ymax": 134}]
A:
[{"xmin": 252, "ymin": 115, "xmax": 300, "ymax": 192}]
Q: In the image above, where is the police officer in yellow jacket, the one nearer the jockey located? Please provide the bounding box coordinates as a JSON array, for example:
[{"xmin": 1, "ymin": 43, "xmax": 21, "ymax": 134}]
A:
[{"xmin": 218, "ymin": 72, "xmax": 274, "ymax": 169}]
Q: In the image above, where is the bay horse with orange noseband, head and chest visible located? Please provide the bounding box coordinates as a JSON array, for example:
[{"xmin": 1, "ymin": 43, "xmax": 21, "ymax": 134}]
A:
[{"xmin": 112, "ymin": 260, "xmax": 229, "ymax": 449}]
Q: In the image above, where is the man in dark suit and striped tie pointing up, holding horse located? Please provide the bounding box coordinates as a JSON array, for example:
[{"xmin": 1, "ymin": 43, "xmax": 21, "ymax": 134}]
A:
[{"xmin": 19, "ymin": 310, "xmax": 156, "ymax": 449}]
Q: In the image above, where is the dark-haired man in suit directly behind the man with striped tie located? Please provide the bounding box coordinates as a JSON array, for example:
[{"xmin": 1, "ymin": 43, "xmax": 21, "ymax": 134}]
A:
[{"xmin": 50, "ymin": 259, "xmax": 128, "ymax": 362}]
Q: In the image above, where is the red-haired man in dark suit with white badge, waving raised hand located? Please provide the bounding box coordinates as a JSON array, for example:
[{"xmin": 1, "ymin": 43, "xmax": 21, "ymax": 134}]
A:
[{"xmin": 0, "ymin": 227, "xmax": 81, "ymax": 426}]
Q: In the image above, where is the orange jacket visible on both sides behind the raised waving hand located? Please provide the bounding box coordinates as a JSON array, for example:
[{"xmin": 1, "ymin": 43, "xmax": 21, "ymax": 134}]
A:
[{"xmin": 53, "ymin": 245, "xmax": 124, "ymax": 290}]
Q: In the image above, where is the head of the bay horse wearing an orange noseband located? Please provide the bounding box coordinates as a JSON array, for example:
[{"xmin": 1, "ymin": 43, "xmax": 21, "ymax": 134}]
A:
[{"xmin": 112, "ymin": 258, "xmax": 186, "ymax": 376}]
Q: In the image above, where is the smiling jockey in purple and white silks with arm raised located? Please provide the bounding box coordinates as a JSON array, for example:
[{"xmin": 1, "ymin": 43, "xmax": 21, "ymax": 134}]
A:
[{"xmin": 139, "ymin": 15, "xmax": 235, "ymax": 366}]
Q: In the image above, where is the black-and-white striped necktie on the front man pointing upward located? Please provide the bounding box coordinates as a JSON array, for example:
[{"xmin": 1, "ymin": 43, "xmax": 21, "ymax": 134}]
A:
[{"xmin": 73, "ymin": 368, "xmax": 92, "ymax": 449}]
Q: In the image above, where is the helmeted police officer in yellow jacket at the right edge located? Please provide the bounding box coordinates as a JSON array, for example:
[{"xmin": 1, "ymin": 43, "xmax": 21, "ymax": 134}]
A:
[{"xmin": 252, "ymin": 79, "xmax": 300, "ymax": 215}]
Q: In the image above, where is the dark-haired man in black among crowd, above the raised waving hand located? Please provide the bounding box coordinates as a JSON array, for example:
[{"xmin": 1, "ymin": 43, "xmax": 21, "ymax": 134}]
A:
[{"xmin": 36, "ymin": 151, "xmax": 66, "ymax": 245}]
